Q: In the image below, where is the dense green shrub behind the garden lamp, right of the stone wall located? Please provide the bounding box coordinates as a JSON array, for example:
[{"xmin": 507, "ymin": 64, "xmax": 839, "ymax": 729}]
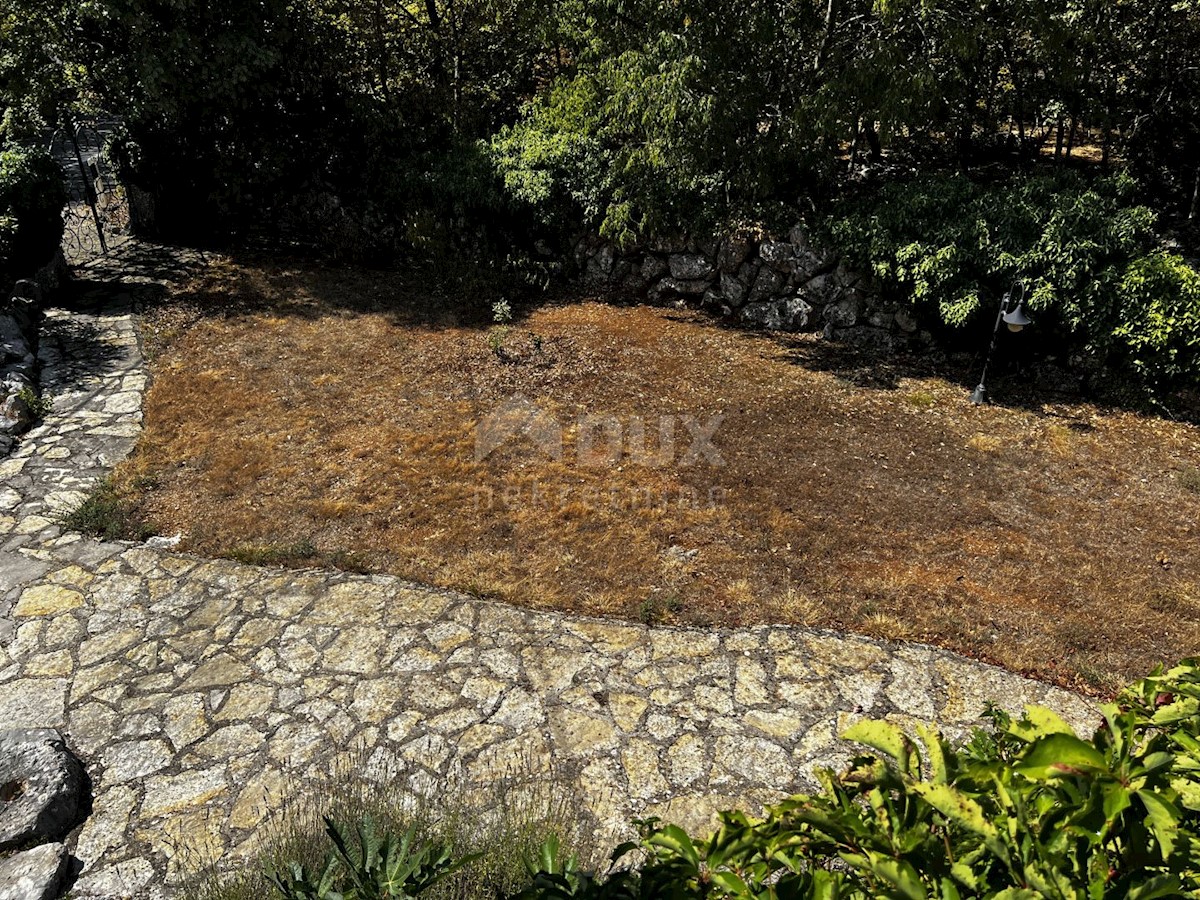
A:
[{"xmin": 829, "ymin": 173, "xmax": 1200, "ymax": 389}]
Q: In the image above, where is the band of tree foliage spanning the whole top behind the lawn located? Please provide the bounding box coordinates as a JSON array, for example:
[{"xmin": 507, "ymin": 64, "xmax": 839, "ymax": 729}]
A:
[{"xmin": 0, "ymin": 0, "xmax": 1200, "ymax": 382}]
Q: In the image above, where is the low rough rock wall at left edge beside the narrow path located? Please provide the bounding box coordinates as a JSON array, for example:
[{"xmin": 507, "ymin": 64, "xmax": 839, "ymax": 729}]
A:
[{"xmin": 0, "ymin": 252, "xmax": 67, "ymax": 456}]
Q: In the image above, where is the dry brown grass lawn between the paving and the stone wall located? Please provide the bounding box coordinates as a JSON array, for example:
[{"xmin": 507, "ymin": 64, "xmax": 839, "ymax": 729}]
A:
[{"xmin": 120, "ymin": 260, "xmax": 1200, "ymax": 691}]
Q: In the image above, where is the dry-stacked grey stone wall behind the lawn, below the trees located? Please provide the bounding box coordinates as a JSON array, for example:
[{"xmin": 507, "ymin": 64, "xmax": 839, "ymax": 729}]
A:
[{"xmin": 574, "ymin": 226, "xmax": 930, "ymax": 350}]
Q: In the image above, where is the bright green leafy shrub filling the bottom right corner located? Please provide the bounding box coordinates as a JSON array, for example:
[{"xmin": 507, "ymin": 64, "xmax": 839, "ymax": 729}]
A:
[{"xmin": 520, "ymin": 659, "xmax": 1200, "ymax": 900}]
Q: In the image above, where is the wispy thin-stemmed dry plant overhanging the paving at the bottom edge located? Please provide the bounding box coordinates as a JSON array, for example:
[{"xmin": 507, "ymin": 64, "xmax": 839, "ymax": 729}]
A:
[{"xmin": 173, "ymin": 754, "xmax": 593, "ymax": 900}]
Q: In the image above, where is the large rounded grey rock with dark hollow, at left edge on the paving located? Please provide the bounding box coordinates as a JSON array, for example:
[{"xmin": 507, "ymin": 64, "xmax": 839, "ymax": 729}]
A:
[{"xmin": 0, "ymin": 728, "xmax": 83, "ymax": 850}]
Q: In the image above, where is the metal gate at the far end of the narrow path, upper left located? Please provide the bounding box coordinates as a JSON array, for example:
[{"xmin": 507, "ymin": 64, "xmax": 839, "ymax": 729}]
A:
[{"xmin": 49, "ymin": 119, "xmax": 130, "ymax": 265}]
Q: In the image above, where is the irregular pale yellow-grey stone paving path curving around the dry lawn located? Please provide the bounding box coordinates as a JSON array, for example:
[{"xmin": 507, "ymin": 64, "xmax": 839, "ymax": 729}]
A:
[{"xmin": 0, "ymin": 247, "xmax": 1094, "ymax": 896}]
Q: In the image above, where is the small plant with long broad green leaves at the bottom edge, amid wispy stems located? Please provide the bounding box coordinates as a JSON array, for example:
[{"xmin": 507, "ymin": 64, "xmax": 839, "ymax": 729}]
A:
[{"xmin": 269, "ymin": 816, "xmax": 479, "ymax": 900}]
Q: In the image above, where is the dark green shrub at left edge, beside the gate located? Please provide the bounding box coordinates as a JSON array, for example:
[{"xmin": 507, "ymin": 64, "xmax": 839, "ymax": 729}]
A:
[{"xmin": 0, "ymin": 146, "xmax": 66, "ymax": 290}]
